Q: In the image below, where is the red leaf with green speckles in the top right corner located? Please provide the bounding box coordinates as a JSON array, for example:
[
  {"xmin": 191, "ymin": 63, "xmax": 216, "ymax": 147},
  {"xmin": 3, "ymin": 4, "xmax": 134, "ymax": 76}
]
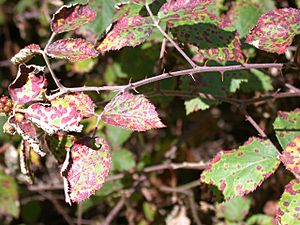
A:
[{"xmin": 246, "ymin": 8, "xmax": 300, "ymax": 54}]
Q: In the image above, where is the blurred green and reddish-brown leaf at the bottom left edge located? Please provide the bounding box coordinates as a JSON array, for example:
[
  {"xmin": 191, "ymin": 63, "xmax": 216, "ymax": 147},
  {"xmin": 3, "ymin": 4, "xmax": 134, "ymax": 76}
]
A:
[{"xmin": 0, "ymin": 171, "xmax": 20, "ymax": 218}]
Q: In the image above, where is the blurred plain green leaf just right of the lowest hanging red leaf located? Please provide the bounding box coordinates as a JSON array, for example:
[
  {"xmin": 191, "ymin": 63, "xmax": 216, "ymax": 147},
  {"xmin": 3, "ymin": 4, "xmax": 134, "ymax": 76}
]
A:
[{"xmin": 111, "ymin": 149, "xmax": 135, "ymax": 172}]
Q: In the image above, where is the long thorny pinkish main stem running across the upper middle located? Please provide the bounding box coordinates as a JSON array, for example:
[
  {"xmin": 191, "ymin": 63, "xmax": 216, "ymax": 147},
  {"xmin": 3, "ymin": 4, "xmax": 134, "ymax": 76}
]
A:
[{"xmin": 50, "ymin": 63, "xmax": 283, "ymax": 99}]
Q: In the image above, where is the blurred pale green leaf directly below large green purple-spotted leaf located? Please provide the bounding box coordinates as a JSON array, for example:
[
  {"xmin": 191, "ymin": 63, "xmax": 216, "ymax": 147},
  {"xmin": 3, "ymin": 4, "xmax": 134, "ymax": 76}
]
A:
[{"xmin": 217, "ymin": 197, "xmax": 251, "ymax": 222}]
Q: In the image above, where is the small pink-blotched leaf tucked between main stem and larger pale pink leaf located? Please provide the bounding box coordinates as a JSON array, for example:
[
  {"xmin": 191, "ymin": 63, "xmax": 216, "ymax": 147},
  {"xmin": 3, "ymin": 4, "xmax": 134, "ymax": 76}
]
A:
[{"xmin": 64, "ymin": 92, "xmax": 95, "ymax": 118}]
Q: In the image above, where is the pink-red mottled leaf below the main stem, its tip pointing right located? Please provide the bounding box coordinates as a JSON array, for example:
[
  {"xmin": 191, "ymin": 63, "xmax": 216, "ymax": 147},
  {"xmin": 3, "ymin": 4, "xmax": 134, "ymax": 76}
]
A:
[{"xmin": 101, "ymin": 93, "xmax": 165, "ymax": 131}]
